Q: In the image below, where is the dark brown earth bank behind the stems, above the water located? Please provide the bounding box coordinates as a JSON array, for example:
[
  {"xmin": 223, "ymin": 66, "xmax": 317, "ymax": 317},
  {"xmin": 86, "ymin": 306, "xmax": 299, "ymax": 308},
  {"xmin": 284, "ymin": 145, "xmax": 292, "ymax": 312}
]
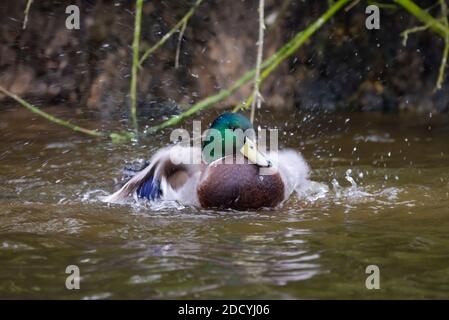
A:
[{"xmin": 0, "ymin": 0, "xmax": 449, "ymax": 114}]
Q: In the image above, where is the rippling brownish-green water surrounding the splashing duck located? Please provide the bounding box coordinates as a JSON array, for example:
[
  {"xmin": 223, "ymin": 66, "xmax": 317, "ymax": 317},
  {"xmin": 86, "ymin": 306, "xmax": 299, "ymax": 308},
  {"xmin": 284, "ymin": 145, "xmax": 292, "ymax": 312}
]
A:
[{"xmin": 0, "ymin": 108, "xmax": 449, "ymax": 299}]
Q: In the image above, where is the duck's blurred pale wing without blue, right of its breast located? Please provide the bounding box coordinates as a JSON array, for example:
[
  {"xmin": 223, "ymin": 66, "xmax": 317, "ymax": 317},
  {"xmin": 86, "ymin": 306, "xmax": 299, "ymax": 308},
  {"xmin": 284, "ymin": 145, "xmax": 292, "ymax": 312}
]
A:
[{"xmin": 277, "ymin": 149, "xmax": 310, "ymax": 199}]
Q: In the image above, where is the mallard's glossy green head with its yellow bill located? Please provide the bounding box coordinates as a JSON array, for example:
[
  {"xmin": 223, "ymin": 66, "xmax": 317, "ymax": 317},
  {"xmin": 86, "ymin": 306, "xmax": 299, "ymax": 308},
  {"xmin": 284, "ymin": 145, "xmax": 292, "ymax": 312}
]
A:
[{"xmin": 202, "ymin": 112, "xmax": 271, "ymax": 167}]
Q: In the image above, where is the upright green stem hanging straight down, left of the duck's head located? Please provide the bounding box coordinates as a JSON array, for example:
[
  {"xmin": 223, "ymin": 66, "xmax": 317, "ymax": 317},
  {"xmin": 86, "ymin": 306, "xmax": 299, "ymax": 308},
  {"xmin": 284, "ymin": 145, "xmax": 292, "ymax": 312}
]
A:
[{"xmin": 130, "ymin": 0, "xmax": 143, "ymax": 134}]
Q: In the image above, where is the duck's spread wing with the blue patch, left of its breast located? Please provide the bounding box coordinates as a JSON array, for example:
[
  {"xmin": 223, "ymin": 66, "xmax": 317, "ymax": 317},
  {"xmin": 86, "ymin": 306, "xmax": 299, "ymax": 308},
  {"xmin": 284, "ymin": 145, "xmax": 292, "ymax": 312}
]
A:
[{"xmin": 104, "ymin": 146, "xmax": 202, "ymax": 205}]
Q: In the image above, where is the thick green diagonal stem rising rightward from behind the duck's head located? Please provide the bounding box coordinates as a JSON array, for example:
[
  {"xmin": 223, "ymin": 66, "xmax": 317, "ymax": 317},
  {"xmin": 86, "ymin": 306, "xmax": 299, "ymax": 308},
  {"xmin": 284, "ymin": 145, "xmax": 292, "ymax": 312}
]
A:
[{"xmin": 148, "ymin": 0, "xmax": 350, "ymax": 133}]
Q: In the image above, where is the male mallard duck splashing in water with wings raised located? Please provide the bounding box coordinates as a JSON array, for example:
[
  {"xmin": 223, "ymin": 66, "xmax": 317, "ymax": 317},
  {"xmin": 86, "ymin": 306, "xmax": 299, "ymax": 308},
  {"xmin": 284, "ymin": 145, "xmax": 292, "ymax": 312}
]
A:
[{"xmin": 105, "ymin": 113, "xmax": 309, "ymax": 210}]
